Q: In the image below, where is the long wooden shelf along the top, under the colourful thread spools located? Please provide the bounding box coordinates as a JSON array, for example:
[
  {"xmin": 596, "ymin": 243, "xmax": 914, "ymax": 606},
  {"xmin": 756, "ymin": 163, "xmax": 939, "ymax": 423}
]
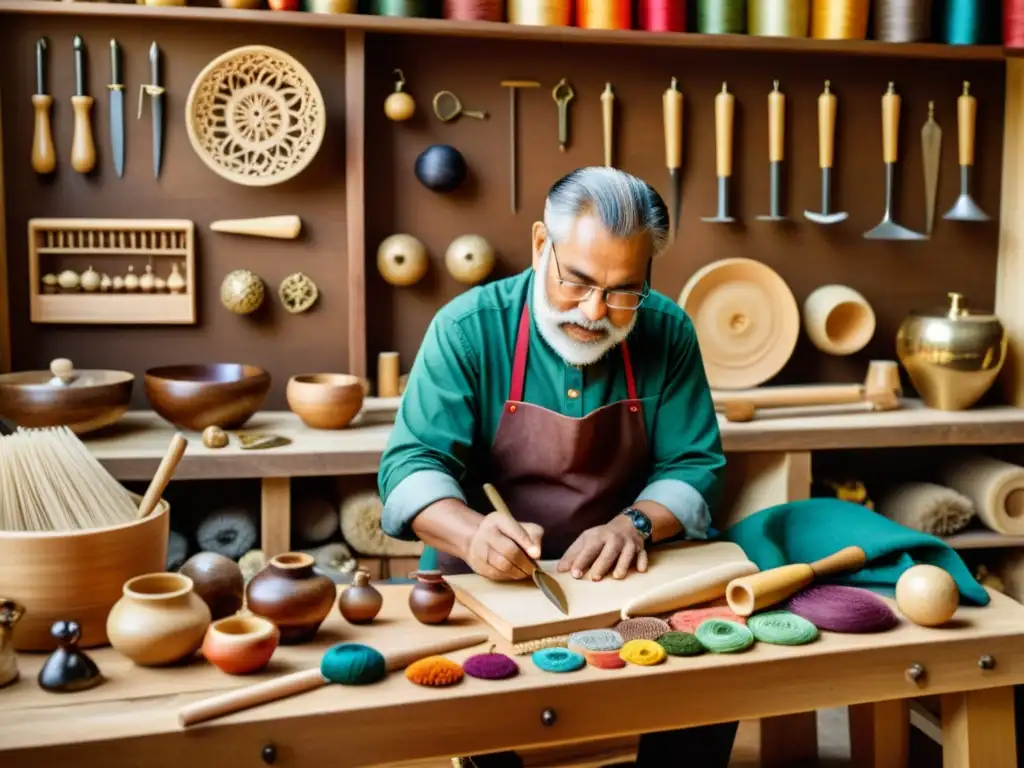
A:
[{"xmin": 0, "ymin": 0, "xmax": 1007, "ymax": 61}]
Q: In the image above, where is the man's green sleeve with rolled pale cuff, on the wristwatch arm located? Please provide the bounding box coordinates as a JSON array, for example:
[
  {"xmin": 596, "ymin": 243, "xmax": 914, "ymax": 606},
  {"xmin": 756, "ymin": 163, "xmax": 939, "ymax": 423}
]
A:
[{"xmin": 637, "ymin": 315, "xmax": 725, "ymax": 539}]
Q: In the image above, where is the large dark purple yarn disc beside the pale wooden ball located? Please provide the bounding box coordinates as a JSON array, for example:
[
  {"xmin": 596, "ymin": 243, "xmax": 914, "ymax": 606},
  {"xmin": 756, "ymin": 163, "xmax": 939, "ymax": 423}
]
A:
[{"xmin": 785, "ymin": 584, "xmax": 899, "ymax": 633}]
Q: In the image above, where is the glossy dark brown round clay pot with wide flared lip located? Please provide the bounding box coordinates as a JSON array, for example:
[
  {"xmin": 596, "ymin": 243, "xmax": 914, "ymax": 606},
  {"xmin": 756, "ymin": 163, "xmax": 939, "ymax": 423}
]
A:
[{"xmin": 246, "ymin": 552, "xmax": 337, "ymax": 645}]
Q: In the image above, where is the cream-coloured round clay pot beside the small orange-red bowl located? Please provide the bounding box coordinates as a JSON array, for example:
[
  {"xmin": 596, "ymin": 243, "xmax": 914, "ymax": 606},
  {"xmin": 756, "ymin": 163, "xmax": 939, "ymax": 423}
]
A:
[{"xmin": 106, "ymin": 573, "xmax": 210, "ymax": 667}]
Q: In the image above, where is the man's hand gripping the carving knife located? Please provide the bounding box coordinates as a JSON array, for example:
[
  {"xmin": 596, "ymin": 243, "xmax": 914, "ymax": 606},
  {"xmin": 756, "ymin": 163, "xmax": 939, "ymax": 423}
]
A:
[{"xmin": 463, "ymin": 512, "xmax": 544, "ymax": 582}]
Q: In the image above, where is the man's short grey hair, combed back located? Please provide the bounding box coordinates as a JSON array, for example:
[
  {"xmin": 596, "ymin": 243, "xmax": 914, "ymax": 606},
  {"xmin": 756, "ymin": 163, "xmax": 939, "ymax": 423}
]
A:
[{"xmin": 544, "ymin": 166, "xmax": 669, "ymax": 257}]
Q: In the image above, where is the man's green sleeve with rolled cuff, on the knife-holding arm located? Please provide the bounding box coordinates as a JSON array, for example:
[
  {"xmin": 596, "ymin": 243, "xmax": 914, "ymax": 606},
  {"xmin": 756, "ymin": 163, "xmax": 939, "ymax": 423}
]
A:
[{"xmin": 377, "ymin": 312, "xmax": 479, "ymax": 541}]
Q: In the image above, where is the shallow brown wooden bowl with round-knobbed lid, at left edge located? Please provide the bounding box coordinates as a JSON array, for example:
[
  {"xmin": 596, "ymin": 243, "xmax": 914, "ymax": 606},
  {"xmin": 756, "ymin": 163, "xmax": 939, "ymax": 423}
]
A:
[{"xmin": 0, "ymin": 371, "xmax": 135, "ymax": 434}]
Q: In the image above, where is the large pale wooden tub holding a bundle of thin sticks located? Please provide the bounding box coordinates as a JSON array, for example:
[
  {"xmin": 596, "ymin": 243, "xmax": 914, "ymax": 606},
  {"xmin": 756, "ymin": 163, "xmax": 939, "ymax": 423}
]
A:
[{"xmin": 0, "ymin": 494, "xmax": 171, "ymax": 651}]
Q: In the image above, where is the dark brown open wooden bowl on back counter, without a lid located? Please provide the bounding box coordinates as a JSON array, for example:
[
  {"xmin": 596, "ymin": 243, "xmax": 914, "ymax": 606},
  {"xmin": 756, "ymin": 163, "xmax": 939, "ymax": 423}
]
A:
[{"xmin": 144, "ymin": 362, "xmax": 270, "ymax": 432}]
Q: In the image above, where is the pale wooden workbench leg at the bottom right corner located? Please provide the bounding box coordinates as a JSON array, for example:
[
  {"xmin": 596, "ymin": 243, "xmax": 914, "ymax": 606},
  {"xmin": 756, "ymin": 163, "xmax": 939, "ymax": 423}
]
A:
[{"xmin": 942, "ymin": 686, "xmax": 1017, "ymax": 768}]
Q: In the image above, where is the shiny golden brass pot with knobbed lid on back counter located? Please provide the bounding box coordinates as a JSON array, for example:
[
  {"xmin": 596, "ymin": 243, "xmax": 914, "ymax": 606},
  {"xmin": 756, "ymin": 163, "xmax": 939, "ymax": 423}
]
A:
[{"xmin": 896, "ymin": 293, "xmax": 1007, "ymax": 411}]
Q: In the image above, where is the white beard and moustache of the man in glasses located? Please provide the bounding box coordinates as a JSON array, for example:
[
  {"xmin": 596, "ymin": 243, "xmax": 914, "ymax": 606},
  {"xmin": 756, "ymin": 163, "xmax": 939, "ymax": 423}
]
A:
[{"xmin": 534, "ymin": 243, "xmax": 637, "ymax": 366}]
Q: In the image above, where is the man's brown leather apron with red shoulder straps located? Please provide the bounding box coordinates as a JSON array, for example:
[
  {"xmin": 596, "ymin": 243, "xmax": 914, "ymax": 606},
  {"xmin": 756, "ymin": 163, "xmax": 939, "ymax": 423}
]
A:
[{"xmin": 437, "ymin": 304, "xmax": 649, "ymax": 573}]
